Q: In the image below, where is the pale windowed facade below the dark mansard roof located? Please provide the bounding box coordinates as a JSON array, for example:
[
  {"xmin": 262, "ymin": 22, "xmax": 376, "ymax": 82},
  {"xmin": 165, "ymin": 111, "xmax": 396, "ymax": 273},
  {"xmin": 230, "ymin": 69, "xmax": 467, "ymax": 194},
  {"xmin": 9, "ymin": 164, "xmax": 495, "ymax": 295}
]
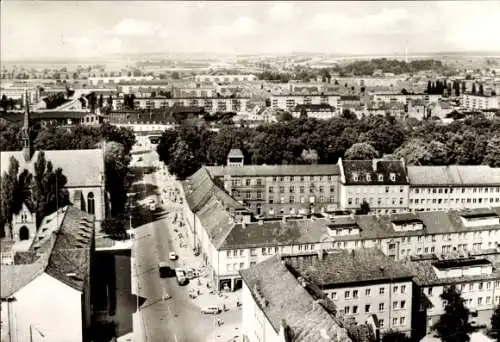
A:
[{"xmin": 340, "ymin": 183, "xmax": 409, "ymax": 214}]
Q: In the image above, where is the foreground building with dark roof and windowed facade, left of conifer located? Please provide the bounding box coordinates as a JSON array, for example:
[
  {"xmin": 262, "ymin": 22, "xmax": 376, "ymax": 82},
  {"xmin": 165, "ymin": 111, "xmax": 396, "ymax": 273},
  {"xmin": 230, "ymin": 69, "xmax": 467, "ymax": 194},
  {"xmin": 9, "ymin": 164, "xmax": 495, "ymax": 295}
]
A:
[{"xmin": 282, "ymin": 248, "xmax": 413, "ymax": 335}]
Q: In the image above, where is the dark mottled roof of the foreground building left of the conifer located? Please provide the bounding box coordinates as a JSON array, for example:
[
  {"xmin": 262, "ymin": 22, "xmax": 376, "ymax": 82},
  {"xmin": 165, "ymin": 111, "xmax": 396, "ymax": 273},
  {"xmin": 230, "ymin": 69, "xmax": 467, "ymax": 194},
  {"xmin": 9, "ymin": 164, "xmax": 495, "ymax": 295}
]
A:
[{"xmin": 283, "ymin": 248, "xmax": 413, "ymax": 287}]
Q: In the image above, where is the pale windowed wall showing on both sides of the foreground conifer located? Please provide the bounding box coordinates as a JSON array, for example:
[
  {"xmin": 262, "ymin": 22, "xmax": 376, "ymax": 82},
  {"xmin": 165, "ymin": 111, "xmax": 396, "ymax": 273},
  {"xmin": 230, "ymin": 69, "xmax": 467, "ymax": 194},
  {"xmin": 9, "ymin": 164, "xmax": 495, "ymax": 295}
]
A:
[{"xmin": 421, "ymin": 279, "xmax": 500, "ymax": 332}]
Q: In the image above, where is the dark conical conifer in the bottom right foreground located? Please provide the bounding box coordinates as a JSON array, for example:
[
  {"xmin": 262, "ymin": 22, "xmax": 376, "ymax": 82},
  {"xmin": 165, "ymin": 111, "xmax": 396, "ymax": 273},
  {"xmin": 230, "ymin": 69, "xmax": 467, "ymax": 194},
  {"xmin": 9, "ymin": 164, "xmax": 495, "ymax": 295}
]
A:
[{"xmin": 432, "ymin": 286, "xmax": 475, "ymax": 342}]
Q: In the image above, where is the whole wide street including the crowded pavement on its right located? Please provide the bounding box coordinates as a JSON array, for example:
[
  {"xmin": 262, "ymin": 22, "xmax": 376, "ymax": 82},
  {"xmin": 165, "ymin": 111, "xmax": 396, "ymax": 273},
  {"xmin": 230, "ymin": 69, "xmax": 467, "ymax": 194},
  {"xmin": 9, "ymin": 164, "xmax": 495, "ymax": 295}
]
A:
[{"xmin": 131, "ymin": 146, "xmax": 241, "ymax": 342}]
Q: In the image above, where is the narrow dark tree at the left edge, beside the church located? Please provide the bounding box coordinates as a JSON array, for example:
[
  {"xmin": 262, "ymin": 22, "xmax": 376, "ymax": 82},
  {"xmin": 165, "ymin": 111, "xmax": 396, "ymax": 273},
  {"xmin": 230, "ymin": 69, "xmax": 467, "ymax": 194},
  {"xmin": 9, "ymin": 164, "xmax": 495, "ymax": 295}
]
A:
[{"xmin": 0, "ymin": 157, "xmax": 19, "ymax": 236}]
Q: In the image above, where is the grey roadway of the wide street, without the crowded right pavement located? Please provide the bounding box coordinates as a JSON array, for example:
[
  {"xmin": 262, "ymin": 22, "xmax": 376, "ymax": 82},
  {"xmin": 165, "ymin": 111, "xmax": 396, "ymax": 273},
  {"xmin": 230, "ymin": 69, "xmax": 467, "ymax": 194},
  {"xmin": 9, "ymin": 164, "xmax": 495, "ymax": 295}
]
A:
[{"xmin": 132, "ymin": 148, "xmax": 240, "ymax": 342}]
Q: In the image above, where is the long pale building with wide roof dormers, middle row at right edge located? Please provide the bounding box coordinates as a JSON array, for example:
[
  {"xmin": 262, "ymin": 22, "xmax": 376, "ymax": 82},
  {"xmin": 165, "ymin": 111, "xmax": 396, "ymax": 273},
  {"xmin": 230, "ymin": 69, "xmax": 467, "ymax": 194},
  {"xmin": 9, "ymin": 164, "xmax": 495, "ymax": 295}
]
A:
[{"xmin": 328, "ymin": 207, "xmax": 500, "ymax": 260}]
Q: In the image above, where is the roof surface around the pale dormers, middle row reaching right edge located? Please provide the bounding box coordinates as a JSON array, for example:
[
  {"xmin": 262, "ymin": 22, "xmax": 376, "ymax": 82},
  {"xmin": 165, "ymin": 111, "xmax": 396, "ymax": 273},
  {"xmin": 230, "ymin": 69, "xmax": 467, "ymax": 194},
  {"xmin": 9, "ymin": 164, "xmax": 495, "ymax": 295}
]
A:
[{"xmin": 335, "ymin": 207, "xmax": 500, "ymax": 241}]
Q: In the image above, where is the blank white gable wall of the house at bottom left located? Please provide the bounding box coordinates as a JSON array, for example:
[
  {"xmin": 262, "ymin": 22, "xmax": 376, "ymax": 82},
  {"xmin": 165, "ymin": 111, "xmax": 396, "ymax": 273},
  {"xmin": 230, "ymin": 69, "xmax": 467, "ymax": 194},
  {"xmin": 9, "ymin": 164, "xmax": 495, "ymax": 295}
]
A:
[{"xmin": 2, "ymin": 274, "xmax": 83, "ymax": 342}]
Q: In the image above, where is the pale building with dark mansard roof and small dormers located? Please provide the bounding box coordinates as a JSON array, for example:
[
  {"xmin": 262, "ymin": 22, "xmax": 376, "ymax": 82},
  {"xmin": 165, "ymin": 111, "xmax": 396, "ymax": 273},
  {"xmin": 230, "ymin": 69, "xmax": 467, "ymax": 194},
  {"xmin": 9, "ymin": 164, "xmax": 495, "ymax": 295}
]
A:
[{"xmin": 338, "ymin": 158, "xmax": 409, "ymax": 214}]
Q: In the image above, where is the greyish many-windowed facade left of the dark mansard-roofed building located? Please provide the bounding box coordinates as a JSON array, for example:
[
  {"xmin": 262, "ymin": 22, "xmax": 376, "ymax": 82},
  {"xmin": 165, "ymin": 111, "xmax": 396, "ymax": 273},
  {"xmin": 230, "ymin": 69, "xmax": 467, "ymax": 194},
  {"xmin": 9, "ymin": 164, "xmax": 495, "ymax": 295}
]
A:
[{"xmin": 219, "ymin": 175, "xmax": 339, "ymax": 216}]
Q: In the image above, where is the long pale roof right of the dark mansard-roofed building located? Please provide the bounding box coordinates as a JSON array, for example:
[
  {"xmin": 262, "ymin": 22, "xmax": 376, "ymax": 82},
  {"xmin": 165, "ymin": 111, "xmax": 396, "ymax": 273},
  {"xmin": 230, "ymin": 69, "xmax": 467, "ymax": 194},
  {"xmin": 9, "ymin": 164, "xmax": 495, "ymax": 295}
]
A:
[{"xmin": 408, "ymin": 165, "xmax": 500, "ymax": 186}]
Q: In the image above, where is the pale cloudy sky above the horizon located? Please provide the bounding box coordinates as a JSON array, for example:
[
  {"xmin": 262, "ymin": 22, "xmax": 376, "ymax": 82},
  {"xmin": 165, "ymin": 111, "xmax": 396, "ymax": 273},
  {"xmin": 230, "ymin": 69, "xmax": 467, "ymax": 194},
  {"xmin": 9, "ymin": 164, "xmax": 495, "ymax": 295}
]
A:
[{"xmin": 0, "ymin": 0, "xmax": 500, "ymax": 61}]
